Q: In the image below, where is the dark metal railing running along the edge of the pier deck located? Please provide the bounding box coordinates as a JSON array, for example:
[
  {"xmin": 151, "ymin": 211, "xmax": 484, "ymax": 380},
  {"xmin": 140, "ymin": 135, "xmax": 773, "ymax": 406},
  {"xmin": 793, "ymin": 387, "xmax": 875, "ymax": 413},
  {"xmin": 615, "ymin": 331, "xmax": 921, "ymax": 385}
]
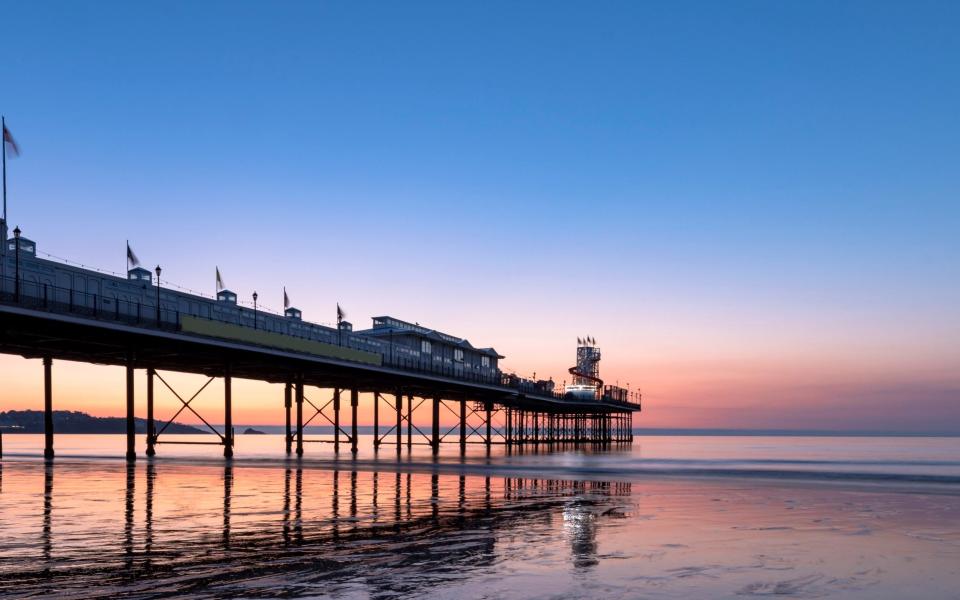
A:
[{"xmin": 0, "ymin": 277, "xmax": 640, "ymax": 410}]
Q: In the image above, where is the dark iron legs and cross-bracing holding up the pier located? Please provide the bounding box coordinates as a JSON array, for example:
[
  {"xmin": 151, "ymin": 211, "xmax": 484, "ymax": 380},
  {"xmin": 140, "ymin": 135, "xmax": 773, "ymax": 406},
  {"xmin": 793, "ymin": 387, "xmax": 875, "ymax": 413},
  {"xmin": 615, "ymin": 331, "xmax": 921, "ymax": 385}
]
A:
[{"xmin": 22, "ymin": 351, "xmax": 633, "ymax": 461}]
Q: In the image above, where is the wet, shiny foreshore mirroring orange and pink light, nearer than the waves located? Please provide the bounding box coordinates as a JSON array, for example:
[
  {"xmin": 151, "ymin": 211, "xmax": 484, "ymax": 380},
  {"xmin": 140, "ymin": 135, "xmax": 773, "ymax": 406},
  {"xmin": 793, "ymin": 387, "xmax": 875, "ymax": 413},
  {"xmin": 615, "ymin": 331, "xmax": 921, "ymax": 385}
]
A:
[{"xmin": 0, "ymin": 442, "xmax": 960, "ymax": 599}]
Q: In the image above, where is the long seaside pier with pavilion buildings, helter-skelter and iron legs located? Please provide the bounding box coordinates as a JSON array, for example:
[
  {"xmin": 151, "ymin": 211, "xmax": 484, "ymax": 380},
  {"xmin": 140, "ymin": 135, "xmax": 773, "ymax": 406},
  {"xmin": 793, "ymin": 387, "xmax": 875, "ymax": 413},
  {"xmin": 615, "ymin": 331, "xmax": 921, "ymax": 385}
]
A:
[{"xmin": 0, "ymin": 221, "xmax": 641, "ymax": 461}]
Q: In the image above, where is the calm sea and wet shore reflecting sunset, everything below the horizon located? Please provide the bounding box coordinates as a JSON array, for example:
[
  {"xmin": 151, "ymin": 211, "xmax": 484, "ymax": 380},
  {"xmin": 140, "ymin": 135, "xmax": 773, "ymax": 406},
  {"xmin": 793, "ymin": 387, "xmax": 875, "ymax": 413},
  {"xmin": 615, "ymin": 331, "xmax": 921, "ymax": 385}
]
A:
[{"xmin": 0, "ymin": 428, "xmax": 960, "ymax": 599}]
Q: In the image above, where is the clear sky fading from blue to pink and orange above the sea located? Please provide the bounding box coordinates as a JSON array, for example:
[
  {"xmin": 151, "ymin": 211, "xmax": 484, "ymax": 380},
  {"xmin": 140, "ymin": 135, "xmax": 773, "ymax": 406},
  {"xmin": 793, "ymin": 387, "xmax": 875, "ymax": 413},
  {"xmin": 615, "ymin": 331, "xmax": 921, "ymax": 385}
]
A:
[{"xmin": 0, "ymin": 1, "xmax": 960, "ymax": 432}]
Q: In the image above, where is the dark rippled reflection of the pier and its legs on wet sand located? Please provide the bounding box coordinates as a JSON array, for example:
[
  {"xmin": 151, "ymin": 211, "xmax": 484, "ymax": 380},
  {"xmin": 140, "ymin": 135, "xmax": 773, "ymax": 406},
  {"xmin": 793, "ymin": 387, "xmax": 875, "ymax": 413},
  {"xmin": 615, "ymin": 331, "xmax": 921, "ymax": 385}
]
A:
[{"xmin": 7, "ymin": 463, "xmax": 630, "ymax": 596}]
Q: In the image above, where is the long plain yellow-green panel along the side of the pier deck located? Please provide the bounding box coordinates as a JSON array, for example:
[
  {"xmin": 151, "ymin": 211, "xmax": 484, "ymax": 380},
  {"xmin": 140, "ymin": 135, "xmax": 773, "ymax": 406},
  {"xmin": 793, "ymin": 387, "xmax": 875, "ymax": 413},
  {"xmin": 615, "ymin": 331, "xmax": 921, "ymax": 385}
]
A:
[{"xmin": 180, "ymin": 315, "xmax": 383, "ymax": 366}]
